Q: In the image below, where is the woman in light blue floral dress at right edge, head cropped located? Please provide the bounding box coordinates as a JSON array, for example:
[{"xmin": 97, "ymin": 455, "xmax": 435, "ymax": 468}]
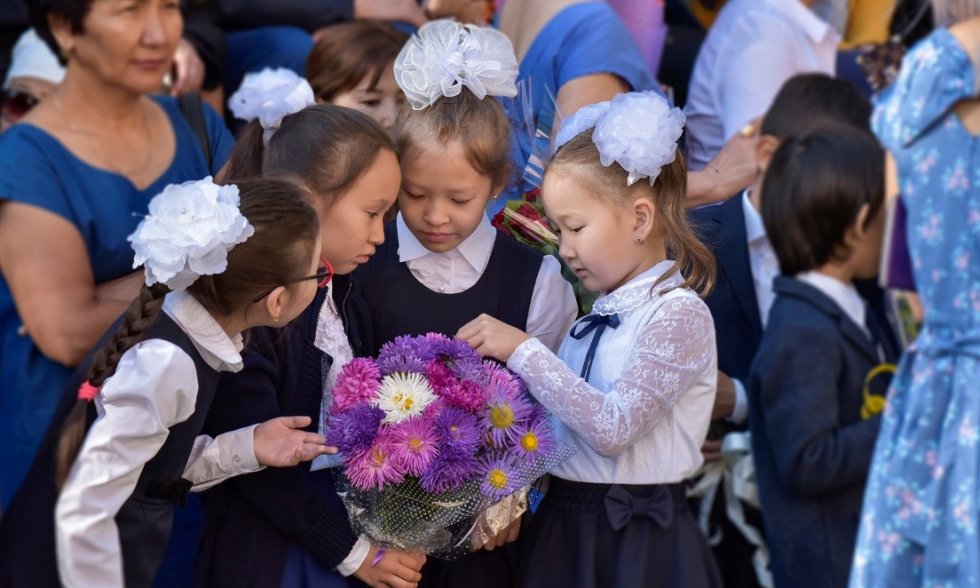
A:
[{"xmin": 851, "ymin": 5, "xmax": 980, "ymax": 588}]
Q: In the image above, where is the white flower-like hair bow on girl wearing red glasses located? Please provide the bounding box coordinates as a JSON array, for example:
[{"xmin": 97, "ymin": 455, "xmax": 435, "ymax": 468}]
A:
[{"xmin": 129, "ymin": 176, "xmax": 255, "ymax": 291}]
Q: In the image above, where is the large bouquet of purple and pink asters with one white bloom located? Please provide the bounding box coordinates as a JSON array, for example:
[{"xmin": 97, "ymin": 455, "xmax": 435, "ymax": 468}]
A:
[{"xmin": 327, "ymin": 333, "xmax": 574, "ymax": 559}]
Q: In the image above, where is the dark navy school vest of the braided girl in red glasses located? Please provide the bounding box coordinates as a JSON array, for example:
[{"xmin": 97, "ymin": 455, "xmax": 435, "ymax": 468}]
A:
[{"xmin": 0, "ymin": 312, "xmax": 218, "ymax": 588}]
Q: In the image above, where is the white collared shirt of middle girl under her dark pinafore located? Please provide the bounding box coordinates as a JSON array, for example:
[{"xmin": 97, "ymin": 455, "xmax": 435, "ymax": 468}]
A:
[{"xmin": 396, "ymin": 214, "xmax": 578, "ymax": 350}]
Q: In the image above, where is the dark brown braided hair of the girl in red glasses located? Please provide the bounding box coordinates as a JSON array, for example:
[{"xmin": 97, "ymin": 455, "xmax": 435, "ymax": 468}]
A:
[{"xmin": 56, "ymin": 179, "xmax": 320, "ymax": 486}]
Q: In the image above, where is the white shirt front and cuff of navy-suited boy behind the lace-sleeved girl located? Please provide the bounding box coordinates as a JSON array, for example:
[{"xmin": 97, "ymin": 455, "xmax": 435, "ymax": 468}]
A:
[{"xmin": 728, "ymin": 190, "xmax": 779, "ymax": 424}]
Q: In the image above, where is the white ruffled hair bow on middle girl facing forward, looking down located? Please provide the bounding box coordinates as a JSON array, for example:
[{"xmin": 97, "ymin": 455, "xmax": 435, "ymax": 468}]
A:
[{"xmin": 395, "ymin": 20, "xmax": 517, "ymax": 110}]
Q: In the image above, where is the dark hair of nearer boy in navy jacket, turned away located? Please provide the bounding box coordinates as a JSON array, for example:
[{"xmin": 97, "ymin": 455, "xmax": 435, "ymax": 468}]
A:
[{"xmin": 761, "ymin": 125, "xmax": 885, "ymax": 276}]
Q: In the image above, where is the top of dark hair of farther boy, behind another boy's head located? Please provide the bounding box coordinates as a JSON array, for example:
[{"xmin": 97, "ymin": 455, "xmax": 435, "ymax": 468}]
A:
[{"xmin": 760, "ymin": 73, "xmax": 871, "ymax": 141}]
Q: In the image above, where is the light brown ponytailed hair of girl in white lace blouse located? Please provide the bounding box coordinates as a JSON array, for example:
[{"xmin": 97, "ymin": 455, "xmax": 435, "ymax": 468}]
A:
[{"xmin": 545, "ymin": 134, "xmax": 715, "ymax": 297}]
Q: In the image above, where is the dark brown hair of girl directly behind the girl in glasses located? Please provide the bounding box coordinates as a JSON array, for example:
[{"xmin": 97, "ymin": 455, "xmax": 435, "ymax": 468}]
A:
[{"xmin": 222, "ymin": 104, "xmax": 395, "ymax": 209}]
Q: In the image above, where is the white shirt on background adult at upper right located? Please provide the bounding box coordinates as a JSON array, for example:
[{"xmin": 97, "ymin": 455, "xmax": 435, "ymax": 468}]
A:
[{"xmin": 684, "ymin": 0, "xmax": 840, "ymax": 170}]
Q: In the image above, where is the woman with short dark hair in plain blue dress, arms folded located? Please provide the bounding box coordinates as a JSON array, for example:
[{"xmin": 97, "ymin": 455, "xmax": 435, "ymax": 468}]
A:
[{"xmin": 0, "ymin": 0, "xmax": 231, "ymax": 510}]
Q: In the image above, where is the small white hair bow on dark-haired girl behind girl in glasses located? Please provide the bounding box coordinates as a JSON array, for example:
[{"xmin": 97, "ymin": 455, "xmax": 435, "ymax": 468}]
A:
[{"xmin": 228, "ymin": 67, "xmax": 316, "ymax": 143}]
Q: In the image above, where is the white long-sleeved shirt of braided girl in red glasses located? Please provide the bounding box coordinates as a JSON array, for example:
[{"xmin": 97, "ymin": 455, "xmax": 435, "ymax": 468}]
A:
[{"xmin": 55, "ymin": 292, "xmax": 261, "ymax": 587}]
